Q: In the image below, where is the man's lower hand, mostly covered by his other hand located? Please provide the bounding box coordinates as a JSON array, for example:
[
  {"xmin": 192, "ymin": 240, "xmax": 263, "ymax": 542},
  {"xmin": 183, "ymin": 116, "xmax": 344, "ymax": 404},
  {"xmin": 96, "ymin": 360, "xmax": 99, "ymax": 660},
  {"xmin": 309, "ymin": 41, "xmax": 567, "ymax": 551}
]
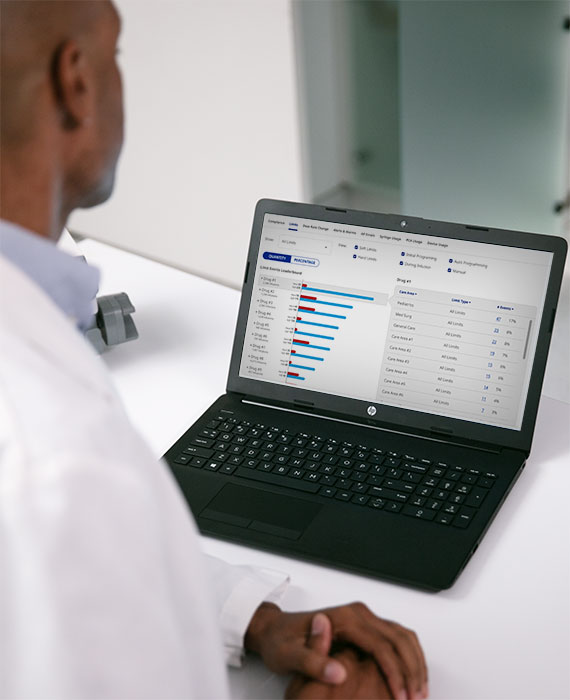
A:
[{"xmin": 285, "ymin": 647, "xmax": 392, "ymax": 700}]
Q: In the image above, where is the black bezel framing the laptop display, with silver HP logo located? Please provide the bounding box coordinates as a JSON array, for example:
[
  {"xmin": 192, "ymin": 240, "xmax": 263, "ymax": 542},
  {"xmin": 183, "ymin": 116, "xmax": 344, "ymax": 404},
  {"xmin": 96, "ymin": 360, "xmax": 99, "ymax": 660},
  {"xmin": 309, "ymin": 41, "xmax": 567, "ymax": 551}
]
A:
[{"xmin": 227, "ymin": 199, "xmax": 567, "ymax": 453}]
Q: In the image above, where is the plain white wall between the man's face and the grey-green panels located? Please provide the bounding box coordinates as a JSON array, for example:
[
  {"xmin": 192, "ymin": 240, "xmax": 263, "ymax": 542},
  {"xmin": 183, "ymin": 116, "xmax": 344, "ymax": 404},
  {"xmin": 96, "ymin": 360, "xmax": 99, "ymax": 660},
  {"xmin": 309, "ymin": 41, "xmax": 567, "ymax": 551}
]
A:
[{"xmin": 70, "ymin": 0, "xmax": 303, "ymax": 287}]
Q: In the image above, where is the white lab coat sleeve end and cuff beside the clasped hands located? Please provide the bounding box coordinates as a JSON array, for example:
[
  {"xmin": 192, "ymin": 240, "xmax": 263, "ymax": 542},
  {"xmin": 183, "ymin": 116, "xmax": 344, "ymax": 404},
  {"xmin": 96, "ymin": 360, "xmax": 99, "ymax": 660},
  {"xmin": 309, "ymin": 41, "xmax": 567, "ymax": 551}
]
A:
[{"xmin": 206, "ymin": 556, "xmax": 289, "ymax": 666}]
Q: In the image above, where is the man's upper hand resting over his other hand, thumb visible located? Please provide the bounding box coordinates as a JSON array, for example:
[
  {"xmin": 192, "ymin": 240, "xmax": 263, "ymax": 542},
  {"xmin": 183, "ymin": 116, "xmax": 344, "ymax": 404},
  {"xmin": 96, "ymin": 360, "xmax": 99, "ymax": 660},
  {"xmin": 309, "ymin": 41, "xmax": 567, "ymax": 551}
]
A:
[{"xmin": 245, "ymin": 603, "xmax": 427, "ymax": 700}]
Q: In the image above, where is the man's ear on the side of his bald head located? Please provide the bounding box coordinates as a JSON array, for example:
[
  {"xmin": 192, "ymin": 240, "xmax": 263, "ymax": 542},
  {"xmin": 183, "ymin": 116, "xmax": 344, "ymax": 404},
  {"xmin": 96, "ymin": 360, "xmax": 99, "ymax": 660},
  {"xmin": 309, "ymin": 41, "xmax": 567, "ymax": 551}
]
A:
[{"xmin": 52, "ymin": 39, "xmax": 92, "ymax": 130}]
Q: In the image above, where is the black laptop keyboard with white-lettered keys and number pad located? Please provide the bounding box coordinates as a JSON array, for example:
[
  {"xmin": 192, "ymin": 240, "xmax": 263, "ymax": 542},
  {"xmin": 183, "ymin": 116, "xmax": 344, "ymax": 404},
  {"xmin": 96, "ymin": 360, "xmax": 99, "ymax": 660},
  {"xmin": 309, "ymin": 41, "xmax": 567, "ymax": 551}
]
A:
[{"xmin": 174, "ymin": 414, "xmax": 497, "ymax": 528}]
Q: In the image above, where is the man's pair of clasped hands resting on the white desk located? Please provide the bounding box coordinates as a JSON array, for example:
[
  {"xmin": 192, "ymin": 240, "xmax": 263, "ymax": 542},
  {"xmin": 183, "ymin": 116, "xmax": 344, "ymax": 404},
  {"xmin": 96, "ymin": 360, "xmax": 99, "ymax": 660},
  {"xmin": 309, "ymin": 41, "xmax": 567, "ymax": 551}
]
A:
[{"xmin": 245, "ymin": 603, "xmax": 428, "ymax": 700}]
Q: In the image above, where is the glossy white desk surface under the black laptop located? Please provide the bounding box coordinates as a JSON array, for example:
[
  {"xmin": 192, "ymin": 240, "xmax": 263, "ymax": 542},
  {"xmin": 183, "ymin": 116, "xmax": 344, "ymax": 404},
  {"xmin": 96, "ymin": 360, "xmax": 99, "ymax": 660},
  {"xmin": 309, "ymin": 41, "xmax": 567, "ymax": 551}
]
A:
[{"xmin": 80, "ymin": 240, "xmax": 570, "ymax": 700}]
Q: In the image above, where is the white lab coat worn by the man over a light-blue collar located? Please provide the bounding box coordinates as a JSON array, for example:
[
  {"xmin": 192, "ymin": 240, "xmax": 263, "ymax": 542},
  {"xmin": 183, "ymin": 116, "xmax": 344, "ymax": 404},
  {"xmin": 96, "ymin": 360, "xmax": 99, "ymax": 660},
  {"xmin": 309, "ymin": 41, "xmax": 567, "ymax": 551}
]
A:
[{"xmin": 0, "ymin": 257, "xmax": 286, "ymax": 698}]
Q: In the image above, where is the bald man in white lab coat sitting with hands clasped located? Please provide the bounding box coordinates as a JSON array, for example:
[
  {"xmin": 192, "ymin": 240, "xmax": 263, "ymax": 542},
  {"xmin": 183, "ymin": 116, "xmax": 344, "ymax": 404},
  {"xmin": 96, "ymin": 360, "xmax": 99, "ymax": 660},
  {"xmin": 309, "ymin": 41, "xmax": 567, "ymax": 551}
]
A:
[{"xmin": 0, "ymin": 0, "xmax": 427, "ymax": 698}]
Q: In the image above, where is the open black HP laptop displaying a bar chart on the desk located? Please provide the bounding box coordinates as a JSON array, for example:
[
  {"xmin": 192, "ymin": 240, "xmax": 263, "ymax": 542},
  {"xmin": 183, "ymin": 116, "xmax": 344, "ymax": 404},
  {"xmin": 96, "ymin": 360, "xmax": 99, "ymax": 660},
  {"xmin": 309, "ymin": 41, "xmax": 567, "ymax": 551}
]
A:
[{"xmin": 165, "ymin": 200, "xmax": 567, "ymax": 590}]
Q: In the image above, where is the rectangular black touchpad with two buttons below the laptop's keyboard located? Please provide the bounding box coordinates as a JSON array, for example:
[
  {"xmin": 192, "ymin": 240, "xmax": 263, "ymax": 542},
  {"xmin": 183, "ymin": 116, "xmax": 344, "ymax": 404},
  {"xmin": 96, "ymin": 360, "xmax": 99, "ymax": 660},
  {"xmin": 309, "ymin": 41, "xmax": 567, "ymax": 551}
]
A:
[{"xmin": 198, "ymin": 484, "xmax": 321, "ymax": 540}]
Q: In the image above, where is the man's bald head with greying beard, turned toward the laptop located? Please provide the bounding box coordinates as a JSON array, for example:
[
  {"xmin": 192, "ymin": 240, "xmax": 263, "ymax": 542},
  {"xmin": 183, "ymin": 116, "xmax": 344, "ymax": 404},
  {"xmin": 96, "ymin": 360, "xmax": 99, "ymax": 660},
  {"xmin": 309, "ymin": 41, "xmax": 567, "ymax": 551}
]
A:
[{"xmin": 0, "ymin": 0, "xmax": 123, "ymax": 238}]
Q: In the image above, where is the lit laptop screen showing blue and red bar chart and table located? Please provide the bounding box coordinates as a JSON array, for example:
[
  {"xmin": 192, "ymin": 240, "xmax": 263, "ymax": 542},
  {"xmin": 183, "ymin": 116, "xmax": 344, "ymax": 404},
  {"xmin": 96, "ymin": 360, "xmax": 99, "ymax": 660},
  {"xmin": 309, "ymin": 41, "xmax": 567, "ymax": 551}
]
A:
[{"xmin": 239, "ymin": 213, "xmax": 553, "ymax": 430}]
